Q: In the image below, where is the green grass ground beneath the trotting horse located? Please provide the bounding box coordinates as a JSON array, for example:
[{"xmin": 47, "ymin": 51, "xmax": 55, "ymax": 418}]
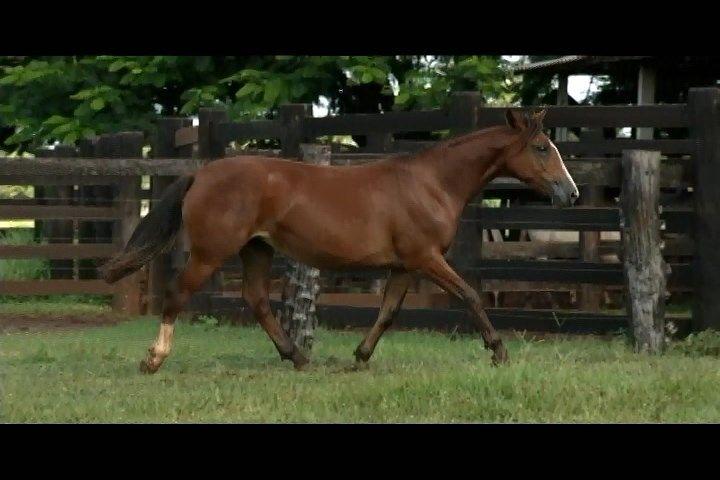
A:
[{"xmin": 0, "ymin": 318, "xmax": 720, "ymax": 422}]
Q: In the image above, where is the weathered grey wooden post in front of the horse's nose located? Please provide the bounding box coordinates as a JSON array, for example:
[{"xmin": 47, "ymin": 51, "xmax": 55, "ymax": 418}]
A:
[{"xmin": 620, "ymin": 150, "xmax": 669, "ymax": 353}]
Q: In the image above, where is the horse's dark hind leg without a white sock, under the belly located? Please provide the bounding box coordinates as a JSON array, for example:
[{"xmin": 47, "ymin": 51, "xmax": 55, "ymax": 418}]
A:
[{"xmin": 240, "ymin": 239, "xmax": 308, "ymax": 369}]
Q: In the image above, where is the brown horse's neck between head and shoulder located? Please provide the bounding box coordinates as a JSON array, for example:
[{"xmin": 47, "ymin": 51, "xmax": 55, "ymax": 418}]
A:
[{"xmin": 414, "ymin": 127, "xmax": 514, "ymax": 208}]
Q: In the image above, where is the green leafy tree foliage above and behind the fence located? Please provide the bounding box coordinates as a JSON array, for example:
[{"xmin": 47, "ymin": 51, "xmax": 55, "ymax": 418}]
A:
[{"xmin": 0, "ymin": 55, "xmax": 514, "ymax": 151}]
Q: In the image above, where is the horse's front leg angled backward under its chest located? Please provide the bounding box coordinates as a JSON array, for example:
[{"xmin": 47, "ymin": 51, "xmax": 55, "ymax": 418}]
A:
[{"xmin": 355, "ymin": 270, "xmax": 412, "ymax": 362}]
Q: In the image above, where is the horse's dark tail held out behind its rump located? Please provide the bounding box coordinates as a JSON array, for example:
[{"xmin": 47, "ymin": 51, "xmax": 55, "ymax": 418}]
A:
[{"xmin": 99, "ymin": 175, "xmax": 194, "ymax": 283}]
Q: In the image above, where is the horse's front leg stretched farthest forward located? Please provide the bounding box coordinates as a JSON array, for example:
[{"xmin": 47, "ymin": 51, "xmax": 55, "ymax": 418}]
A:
[{"xmin": 420, "ymin": 253, "xmax": 508, "ymax": 364}]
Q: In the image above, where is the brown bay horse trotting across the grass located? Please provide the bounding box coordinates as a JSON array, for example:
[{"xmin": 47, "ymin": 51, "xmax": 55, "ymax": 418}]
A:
[{"xmin": 103, "ymin": 110, "xmax": 578, "ymax": 373}]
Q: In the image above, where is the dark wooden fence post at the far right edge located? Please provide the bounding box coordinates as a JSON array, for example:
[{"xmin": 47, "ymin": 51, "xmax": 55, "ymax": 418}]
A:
[{"xmin": 688, "ymin": 87, "xmax": 720, "ymax": 331}]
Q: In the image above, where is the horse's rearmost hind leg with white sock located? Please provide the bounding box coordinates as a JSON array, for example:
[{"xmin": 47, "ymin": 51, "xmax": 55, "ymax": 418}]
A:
[{"xmin": 140, "ymin": 251, "xmax": 220, "ymax": 373}]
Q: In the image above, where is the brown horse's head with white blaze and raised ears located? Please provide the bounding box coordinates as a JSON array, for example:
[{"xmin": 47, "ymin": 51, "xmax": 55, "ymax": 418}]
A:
[{"xmin": 505, "ymin": 110, "xmax": 579, "ymax": 207}]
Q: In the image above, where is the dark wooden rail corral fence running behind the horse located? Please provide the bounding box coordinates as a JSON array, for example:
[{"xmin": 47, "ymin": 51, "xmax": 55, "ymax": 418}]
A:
[{"xmin": 0, "ymin": 88, "xmax": 720, "ymax": 332}]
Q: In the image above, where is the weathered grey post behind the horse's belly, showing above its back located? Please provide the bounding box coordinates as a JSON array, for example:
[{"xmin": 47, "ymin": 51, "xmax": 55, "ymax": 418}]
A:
[{"xmin": 277, "ymin": 144, "xmax": 331, "ymax": 354}]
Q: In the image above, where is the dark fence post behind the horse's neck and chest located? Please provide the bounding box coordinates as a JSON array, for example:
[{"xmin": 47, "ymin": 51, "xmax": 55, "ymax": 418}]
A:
[{"xmin": 448, "ymin": 92, "xmax": 483, "ymax": 306}]
